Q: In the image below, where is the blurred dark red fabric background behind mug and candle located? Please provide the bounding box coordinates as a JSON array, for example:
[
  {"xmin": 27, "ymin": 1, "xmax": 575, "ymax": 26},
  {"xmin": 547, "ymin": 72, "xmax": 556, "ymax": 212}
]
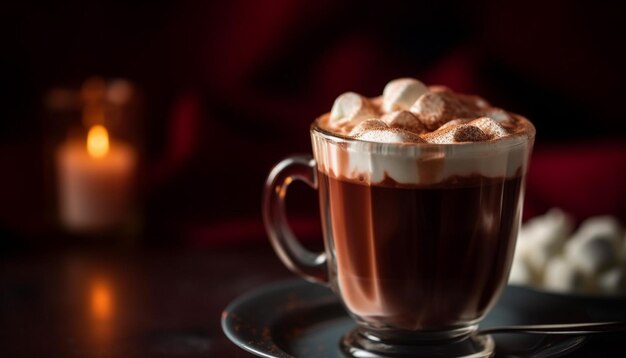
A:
[{"xmin": 0, "ymin": 0, "xmax": 626, "ymax": 250}]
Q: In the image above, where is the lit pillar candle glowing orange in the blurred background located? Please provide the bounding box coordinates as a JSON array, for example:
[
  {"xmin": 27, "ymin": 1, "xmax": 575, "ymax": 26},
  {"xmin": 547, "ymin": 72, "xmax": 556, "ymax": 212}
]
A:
[{"xmin": 57, "ymin": 125, "xmax": 136, "ymax": 231}]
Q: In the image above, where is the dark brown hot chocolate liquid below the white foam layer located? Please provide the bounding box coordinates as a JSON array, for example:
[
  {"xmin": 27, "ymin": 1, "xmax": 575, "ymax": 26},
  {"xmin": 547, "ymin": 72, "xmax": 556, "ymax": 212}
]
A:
[{"xmin": 319, "ymin": 172, "xmax": 522, "ymax": 330}]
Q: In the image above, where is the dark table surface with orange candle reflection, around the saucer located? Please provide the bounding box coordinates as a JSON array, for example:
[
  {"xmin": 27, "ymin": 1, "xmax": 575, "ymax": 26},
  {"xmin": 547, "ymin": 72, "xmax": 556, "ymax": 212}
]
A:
[{"xmin": 0, "ymin": 243, "xmax": 626, "ymax": 357}]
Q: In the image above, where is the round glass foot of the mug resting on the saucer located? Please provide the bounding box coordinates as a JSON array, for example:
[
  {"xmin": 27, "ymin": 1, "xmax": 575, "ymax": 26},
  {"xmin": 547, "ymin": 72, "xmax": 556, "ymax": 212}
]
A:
[{"xmin": 341, "ymin": 328, "xmax": 495, "ymax": 358}]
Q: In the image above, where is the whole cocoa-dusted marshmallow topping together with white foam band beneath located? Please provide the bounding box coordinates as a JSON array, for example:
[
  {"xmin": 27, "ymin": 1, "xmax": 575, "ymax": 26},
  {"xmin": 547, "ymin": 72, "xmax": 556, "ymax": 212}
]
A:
[{"xmin": 313, "ymin": 78, "xmax": 535, "ymax": 185}]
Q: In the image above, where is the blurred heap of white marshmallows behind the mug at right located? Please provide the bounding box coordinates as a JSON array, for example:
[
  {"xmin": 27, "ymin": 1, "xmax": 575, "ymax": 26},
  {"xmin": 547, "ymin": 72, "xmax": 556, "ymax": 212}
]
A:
[{"xmin": 509, "ymin": 208, "xmax": 626, "ymax": 297}]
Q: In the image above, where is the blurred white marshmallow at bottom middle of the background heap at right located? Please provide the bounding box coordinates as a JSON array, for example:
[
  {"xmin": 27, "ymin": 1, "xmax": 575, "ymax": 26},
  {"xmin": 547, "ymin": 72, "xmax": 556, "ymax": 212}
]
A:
[{"xmin": 543, "ymin": 255, "xmax": 585, "ymax": 292}]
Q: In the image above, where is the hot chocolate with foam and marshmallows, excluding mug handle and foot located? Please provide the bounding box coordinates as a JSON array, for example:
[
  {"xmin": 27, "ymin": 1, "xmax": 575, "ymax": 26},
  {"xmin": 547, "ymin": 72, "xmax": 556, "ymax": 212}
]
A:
[{"xmin": 313, "ymin": 79, "xmax": 534, "ymax": 330}]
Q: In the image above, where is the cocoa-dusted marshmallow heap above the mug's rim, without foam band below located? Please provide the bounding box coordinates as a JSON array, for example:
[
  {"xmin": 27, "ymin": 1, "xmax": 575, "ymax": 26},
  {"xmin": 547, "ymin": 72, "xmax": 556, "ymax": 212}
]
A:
[{"xmin": 319, "ymin": 78, "xmax": 532, "ymax": 144}]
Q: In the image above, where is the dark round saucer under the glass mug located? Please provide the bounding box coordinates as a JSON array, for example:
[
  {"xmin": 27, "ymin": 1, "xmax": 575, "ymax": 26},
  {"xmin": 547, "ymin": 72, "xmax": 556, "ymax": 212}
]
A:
[{"xmin": 222, "ymin": 280, "xmax": 604, "ymax": 358}]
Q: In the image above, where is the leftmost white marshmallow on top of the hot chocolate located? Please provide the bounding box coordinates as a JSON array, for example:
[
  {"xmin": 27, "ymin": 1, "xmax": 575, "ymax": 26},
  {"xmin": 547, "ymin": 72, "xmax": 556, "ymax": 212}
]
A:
[{"xmin": 329, "ymin": 92, "xmax": 376, "ymax": 127}]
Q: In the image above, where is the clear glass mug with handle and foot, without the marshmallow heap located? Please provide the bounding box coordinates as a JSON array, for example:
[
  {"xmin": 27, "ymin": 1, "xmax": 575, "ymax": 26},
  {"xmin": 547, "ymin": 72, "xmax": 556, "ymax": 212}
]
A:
[{"xmin": 263, "ymin": 119, "xmax": 535, "ymax": 357}]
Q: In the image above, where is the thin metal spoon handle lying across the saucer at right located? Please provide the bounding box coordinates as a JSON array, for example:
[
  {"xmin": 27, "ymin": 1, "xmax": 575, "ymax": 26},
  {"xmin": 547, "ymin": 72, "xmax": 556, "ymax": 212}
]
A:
[{"xmin": 478, "ymin": 321, "xmax": 626, "ymax": 335}]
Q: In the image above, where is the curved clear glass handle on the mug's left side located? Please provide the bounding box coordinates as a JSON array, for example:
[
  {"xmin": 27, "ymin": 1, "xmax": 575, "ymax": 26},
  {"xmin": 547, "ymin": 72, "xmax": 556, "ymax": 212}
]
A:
[{"xmin": 263, "ymin": 155, "xmax": 328, "ymax": 284}]
